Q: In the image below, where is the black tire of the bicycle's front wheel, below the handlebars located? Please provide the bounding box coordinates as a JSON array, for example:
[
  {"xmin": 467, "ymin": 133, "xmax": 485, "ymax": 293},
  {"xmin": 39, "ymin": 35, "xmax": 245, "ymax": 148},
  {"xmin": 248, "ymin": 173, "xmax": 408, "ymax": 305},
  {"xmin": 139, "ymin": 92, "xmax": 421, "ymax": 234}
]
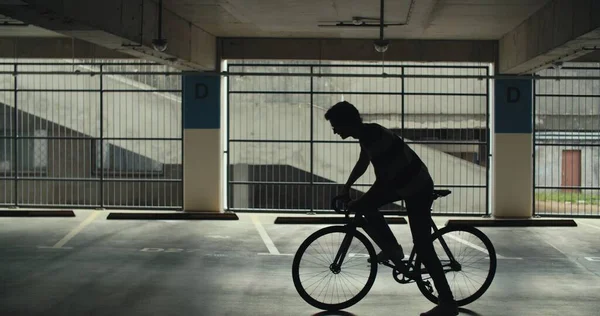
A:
[{"xmin": 292, "ymin": 226, "xmax": 377, "ymax": 311}]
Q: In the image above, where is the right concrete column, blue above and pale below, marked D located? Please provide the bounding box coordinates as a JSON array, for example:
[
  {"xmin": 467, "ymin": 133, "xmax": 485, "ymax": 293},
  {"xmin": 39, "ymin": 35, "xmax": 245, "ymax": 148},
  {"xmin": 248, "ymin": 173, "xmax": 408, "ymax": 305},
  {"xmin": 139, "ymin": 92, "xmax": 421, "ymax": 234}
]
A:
[{"xmin": 492, "ymin": 79, "xmax": 533, "ymax": 218}]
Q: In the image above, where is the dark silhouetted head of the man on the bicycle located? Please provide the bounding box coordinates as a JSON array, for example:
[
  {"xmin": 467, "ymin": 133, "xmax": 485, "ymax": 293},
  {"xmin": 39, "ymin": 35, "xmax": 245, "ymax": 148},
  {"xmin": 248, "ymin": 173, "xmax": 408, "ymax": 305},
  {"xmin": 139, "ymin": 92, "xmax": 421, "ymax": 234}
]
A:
[{"xmin": 325, "ymin": 101, "xmax": 362, "ymax": 139}]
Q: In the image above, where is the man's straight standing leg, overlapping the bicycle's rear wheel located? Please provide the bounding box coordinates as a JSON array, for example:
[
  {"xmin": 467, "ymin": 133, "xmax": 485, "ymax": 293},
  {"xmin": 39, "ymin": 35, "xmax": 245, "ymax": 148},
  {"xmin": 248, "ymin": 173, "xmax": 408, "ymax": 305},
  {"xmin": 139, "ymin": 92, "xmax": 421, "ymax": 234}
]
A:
[{"xmin": 406, "ymin": 190, "xmax": 454, "ymax": 305}]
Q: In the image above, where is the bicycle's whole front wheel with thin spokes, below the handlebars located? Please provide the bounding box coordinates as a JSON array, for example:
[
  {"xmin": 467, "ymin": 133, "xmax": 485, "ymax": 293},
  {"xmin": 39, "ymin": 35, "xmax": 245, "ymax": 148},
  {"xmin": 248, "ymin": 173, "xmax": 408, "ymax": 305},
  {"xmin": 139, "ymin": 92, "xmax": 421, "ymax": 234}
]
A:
[{"xmin": 292, "ymin": 226, "xmax": 377, "ymax": 311}]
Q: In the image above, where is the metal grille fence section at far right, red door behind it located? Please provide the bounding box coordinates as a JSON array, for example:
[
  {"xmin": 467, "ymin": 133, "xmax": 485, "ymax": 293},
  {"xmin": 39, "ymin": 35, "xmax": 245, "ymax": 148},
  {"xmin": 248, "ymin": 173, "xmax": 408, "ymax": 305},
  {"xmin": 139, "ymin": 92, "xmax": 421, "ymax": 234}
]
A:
[{"xmin": 534, "ymin": 63, "xmax": 600, "ymax": 217}]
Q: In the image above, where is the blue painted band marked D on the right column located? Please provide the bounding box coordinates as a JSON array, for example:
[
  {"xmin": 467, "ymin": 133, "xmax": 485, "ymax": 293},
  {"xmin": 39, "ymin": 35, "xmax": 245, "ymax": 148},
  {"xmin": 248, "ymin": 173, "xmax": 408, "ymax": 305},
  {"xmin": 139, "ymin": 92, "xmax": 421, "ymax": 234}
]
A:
[{"xmin": 494, "ymin": 79, "xmax": 533, "ymax": 133}]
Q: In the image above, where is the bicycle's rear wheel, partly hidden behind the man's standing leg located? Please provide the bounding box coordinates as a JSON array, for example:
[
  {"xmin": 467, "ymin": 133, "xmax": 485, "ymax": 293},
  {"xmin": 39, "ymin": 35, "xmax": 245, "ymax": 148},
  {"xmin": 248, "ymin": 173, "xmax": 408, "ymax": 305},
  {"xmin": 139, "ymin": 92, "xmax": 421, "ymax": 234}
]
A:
[{"xmin": 415, "ymin": 226, "xmax": 497, "ymax": 306}]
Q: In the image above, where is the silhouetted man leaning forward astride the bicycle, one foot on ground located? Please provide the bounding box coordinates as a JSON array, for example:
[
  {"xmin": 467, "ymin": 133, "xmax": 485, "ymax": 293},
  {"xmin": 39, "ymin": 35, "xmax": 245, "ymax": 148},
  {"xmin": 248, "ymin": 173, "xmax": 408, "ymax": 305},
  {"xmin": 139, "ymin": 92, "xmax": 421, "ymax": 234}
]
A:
[{"xmin": 325, "ymin": 101, "xmax": 458, "ymax": 316}]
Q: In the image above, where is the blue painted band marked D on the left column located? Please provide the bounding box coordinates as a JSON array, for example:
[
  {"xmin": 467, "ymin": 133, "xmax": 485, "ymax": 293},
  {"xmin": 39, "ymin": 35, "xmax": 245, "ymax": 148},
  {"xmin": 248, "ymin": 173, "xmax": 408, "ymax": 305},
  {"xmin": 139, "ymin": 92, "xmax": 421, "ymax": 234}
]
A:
[{"xmin": 183, "ymin": 72, "xmax": 221, "ymax": 129}]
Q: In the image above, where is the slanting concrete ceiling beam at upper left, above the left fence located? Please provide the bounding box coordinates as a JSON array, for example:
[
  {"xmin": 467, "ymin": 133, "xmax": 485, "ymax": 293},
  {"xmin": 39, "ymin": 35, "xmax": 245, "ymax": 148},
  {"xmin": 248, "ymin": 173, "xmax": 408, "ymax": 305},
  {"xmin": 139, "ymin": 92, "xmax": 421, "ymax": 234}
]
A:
[{"xmin": 0, "ymin": 0, "xmax": 217, "ymax": 70}]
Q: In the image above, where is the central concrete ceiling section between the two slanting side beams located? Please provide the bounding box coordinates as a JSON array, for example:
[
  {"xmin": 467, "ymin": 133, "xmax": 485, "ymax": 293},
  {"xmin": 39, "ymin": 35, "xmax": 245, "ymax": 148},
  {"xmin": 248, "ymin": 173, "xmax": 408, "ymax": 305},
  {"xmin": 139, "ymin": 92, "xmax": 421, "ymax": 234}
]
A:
[{"xmin": 164, "ymin": 0, "xmax": 549, "ymax": 40}]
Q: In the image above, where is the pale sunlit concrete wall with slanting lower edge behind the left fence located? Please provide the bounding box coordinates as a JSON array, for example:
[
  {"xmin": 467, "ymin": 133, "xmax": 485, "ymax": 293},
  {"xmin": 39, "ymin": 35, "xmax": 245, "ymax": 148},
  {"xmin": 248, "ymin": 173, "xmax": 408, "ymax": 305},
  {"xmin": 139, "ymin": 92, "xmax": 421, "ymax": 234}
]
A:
[{"xmin": 0, "ymin": 65, "xmax": 182, "ymax": 164}]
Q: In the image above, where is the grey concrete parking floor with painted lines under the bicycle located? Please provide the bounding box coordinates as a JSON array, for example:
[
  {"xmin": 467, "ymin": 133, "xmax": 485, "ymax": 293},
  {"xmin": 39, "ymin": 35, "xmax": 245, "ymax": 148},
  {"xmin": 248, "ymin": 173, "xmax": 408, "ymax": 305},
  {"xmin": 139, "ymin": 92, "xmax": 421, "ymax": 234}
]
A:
[{"xmin": 0, "ymin": 210, "xmax": 600, "ymax": 316}]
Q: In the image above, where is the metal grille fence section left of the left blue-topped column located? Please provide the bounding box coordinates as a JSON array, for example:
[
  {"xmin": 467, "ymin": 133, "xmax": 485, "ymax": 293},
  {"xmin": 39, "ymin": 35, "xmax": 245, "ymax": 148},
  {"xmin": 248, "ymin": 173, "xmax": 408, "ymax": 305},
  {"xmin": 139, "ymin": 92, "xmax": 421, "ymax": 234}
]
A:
[{"xmin": 0, "ymin": 59, "xmax": 183, "ymax": 209}]
